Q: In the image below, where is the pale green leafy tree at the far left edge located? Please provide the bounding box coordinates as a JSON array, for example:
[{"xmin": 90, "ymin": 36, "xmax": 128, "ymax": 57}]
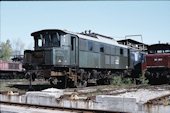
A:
[{"xmin": 0, "ymin": 40, "xmax": 12, "ymax": 61}]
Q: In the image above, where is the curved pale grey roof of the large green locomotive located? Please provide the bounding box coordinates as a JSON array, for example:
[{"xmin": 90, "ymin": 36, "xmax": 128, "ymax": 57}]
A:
[{"xmin": 31, "ymin": 29, "xmax": 128, "ymax": 48}]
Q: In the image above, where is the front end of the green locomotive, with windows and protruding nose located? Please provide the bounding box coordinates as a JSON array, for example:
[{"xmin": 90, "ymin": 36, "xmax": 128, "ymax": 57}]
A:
[{"xmin": 24, "ymin": 30, "xmax": 70, "ymax": 79}]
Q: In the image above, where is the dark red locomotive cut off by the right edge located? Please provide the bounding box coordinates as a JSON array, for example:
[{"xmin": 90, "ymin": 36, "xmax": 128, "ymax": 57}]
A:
[{"xmin": 145, "ymin": 44, "xmax": 170, "ymax": 84}]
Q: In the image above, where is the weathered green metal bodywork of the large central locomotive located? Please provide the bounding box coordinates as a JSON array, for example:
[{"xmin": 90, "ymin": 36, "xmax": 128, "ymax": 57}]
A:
[{"xmin": 24, "ymin": 31, "xmax": 133, "ymax": 69}]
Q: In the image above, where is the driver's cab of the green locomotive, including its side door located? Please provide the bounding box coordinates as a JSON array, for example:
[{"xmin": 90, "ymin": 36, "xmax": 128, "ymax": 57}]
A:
[{"xmin": 25, "ymin": 30, "xmax": 78, "ymax": 67}]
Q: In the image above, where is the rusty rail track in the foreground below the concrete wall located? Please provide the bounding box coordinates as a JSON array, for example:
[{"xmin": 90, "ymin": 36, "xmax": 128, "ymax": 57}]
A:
[{"xmin": 0, "ymin": 101, "xmax": 127, "ymax": 113}]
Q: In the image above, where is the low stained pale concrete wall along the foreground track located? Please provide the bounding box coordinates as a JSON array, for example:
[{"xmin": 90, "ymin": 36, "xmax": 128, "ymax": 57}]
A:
[{"xmin": 0, "ymin": 94, "xmax": 170, "ymax": 113}]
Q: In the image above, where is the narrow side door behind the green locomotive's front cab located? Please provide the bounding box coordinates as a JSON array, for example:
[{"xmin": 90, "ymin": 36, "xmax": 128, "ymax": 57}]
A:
[{"xmin": 70, "ymin": 36, "xmax": 78, "ymax": 66}]
